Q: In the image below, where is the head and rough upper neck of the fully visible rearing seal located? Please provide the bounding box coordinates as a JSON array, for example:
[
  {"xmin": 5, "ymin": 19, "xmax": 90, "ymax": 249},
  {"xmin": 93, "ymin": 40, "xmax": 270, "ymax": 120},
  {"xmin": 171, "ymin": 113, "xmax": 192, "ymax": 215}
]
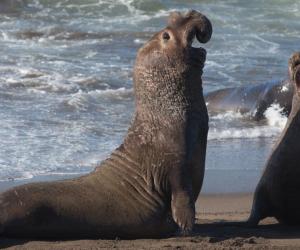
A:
[{"xmin": 134, "ymin": 10, "xmax": 212, "ymax": 113}]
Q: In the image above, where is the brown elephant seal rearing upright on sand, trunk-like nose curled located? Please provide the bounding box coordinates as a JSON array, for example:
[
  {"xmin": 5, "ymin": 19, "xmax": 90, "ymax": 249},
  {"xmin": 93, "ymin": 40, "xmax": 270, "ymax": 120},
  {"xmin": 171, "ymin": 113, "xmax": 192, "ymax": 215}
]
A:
[{"xmin": 0, "ymin": 10, "xmax": 212, "ymax": 239}]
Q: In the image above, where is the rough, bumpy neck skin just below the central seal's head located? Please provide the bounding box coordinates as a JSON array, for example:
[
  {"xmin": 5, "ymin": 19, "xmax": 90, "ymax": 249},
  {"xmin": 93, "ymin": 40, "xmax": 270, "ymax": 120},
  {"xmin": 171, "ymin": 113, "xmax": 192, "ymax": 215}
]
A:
[{"xmin": 134, "ymin": 51, "xmax": 204, "ymax": 117}]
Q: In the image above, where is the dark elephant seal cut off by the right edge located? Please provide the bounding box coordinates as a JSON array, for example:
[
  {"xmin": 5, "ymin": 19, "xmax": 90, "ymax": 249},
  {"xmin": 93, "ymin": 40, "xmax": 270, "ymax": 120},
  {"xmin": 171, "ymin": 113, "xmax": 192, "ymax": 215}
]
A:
[{"xmin": 247, "ymin": 52, "xmax": 300, "ymax": 226}]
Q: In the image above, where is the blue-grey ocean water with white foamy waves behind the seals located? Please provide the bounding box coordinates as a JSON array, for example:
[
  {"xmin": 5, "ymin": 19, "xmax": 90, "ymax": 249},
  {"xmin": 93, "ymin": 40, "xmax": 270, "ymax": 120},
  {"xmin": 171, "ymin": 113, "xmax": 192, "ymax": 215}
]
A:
[{"xmin": 0, "ymin": 0, "xmax": 300, "ymax": 192}]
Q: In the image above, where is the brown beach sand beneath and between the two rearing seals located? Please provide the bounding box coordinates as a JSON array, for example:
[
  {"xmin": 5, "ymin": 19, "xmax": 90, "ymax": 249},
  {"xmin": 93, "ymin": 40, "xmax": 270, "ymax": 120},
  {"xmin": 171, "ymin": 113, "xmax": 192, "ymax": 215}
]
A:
[{"xmin": 0, "ymin": 194, "xmax": 300, "ymax": 249}]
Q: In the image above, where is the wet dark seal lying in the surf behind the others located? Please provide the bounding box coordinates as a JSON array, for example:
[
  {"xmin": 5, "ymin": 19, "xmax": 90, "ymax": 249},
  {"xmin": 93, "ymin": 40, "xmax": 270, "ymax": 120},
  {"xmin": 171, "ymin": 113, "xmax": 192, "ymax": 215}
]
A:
[{"xmin": 204, "ymin": 80, "xmax": 294, "ymax": 121}]
